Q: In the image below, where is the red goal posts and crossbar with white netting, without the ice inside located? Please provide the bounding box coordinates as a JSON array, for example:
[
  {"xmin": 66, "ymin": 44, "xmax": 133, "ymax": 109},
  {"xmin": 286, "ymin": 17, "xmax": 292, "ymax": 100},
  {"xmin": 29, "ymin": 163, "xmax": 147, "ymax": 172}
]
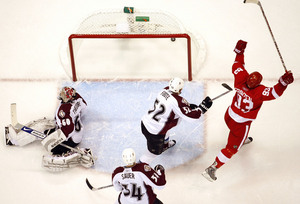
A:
[{"xmin": 64, "ymin": 7, "xmax": 205, "ymax": 81}]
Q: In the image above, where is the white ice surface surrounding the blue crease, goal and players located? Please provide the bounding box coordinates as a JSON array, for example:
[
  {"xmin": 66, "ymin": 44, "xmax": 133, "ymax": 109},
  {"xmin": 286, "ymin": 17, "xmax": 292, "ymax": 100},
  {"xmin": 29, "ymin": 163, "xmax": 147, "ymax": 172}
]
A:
[{"xmin": 0, "ymin": 0, "xmax": 300, "ymax": 204}]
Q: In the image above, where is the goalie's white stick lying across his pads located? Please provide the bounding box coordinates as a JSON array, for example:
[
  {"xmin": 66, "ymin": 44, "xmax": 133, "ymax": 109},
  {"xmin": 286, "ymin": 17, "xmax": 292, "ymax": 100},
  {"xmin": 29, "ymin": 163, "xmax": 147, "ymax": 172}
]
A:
[{"xmin": 10, "ymin": 103, "xmax": 97, "ymax": 160}]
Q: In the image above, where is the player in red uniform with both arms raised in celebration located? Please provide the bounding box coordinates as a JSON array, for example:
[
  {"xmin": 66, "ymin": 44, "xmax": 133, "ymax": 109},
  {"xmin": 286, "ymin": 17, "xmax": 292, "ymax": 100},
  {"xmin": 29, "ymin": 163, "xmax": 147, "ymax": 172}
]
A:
[{"xmin": 202, "ymin": 40, "xmax": 294, "ymax": 181}]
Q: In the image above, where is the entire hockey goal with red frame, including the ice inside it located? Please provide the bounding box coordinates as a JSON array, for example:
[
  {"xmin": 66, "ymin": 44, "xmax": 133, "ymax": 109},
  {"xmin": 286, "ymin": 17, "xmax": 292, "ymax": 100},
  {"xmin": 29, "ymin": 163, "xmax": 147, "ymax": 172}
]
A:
[{"xmin": 60, "ymin": 7, "xmax": 205, "ymax": 81}]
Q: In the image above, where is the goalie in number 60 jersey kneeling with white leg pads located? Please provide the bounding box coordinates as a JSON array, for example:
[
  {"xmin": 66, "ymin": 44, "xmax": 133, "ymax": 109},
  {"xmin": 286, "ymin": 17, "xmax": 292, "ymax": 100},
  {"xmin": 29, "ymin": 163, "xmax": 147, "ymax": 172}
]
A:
[{"xmin": 5, "ymin": 86, "xmax": 94, "ymax": 171}]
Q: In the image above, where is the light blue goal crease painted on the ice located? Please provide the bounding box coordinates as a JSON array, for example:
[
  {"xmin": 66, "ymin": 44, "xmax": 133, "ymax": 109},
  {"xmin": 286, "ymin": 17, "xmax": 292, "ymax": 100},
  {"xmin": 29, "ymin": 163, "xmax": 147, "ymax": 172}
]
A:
[{"xmin": 63, "ymin": 81, "xmax": 204, "ymax": 173}]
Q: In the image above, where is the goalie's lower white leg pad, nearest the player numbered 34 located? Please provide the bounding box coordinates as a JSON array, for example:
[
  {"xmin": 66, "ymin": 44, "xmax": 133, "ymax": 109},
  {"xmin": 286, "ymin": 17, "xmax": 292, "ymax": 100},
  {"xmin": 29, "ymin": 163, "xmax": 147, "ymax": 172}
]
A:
[{"xmin": 42, "ymin": 151, "xmax": 81, "ymax": 172}]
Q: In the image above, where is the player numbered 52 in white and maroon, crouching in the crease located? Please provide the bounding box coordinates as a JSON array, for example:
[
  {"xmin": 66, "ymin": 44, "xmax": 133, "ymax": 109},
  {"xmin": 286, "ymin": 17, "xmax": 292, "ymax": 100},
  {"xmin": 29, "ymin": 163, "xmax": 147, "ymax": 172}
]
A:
[{"xmin": 140, "ymin": 78, "xmax": 212, "ymax": 164}]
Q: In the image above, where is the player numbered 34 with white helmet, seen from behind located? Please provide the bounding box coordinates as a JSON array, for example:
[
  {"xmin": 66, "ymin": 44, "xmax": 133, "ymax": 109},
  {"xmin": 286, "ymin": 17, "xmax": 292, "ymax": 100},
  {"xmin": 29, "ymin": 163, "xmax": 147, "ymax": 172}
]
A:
[{"xmin": 112, "ymin": 148, "xmax": 166, "ymax": 204}]
